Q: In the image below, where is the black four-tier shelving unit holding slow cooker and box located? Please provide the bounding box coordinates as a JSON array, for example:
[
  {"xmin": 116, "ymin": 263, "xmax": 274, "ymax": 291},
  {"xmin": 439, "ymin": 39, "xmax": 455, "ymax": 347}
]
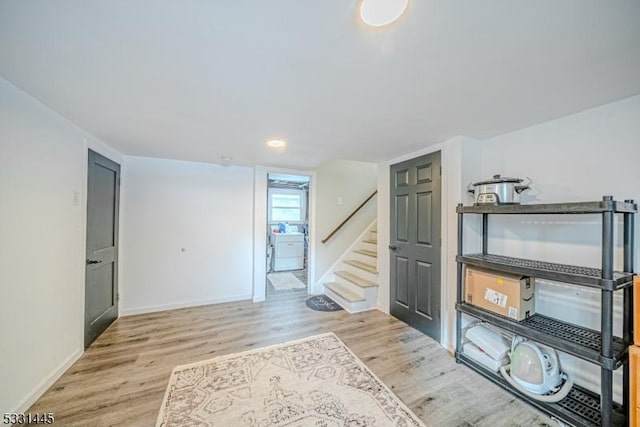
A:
[{"xmin": 456, "ymin": 196, "xmax": 638, "ymax": 427}]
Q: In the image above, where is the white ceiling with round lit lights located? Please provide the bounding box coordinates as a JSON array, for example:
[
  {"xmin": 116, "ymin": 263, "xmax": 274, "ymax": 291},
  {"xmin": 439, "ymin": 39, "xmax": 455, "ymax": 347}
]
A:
[{"xmin": 0, "ymin": 0, "xmax": 640, "ymax": 169}]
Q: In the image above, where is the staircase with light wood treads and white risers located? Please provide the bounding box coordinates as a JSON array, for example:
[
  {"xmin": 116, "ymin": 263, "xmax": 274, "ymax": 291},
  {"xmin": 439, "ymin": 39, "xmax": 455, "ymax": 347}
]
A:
[{"xmin": 324, "ymin": 222, "xmax": 378, "ymax": 313}]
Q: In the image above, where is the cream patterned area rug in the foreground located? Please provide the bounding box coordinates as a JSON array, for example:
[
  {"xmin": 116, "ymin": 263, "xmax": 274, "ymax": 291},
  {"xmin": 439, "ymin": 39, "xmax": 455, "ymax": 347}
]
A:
[{"xmin": 156, "ymin": 333, "xmax": 424, "ymax": 427}]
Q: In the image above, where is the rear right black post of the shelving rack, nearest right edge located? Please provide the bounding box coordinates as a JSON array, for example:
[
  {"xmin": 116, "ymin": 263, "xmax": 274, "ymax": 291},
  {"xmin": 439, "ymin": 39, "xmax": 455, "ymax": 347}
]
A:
[{"xmin": 622, "ymin": 200, "xmax": 634, "ymax": 418}]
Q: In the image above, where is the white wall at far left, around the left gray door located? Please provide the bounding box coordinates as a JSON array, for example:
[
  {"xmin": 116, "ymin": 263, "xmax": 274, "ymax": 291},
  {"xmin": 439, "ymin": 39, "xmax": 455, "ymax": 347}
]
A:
[{"xmin": 0, "ymin": 78, "xmax": 121, "ymax": 413}]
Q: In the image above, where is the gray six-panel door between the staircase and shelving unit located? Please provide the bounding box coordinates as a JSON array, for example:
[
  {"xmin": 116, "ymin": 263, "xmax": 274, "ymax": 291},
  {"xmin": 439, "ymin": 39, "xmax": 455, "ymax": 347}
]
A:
[{"xmin": 389, "ymin": 152, "xmax": 441, "ymax": 341}]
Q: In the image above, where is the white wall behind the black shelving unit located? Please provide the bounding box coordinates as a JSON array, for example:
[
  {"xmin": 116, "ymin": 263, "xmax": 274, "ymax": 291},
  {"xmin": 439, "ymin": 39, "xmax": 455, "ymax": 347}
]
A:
[{"xmin": 470, "ymin": 96, "xmax": 640, "ymax": 400}]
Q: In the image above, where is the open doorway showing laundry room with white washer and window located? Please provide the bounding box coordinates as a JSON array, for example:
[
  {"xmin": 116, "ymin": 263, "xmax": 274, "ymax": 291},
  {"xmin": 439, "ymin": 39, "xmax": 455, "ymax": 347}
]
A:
[{"xmin": 266, "ymin": 173, "xmax": 309, "ymax": 298}]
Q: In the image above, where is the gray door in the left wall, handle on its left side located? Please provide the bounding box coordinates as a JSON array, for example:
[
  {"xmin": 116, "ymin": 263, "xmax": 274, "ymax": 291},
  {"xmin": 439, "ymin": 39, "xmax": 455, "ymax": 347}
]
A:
[{"xmin": 84, "ymin": 150, "xmax": 120, "ymax": 348}]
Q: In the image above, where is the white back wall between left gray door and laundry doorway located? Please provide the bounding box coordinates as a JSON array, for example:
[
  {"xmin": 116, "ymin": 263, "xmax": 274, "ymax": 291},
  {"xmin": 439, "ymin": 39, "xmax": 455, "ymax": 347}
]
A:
[{"xmin": 120, "ymin": 157, "xmax": 254, "ymax": 314}]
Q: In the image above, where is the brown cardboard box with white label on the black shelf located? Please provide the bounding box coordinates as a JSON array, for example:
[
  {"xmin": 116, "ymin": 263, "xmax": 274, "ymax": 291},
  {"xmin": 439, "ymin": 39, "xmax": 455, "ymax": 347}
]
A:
[{"xmin": 465, "ymin": 266, "xmax": 535, "ymax": 320}]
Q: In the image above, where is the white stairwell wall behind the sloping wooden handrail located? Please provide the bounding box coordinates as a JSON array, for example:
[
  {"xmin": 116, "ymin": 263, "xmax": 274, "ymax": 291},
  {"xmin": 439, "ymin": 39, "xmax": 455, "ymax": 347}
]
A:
[{"xmin": 313, "ymin": 160, "xmax": 379, "ymax": 292}]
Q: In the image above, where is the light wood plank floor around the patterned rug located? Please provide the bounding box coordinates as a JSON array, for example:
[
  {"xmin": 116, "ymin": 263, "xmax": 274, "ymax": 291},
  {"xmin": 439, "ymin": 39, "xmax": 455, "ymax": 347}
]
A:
[{"xmin": 29, "ymin": 290, "xmax": 550, "ymax": 427}]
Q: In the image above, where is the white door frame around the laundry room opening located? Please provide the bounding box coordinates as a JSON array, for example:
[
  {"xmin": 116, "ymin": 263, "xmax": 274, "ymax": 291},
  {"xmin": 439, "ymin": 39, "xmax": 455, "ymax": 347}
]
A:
[{"xmin": 253, "ymin": 166, "xmax": 316, "ymax": 302}]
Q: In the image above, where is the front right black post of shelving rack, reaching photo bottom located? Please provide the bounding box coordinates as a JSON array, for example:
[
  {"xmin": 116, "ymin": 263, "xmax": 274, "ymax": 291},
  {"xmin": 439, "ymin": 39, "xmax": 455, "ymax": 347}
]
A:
[{"xmin": 600, "ymin": 196, "xmax": 614, "ymax": 426}]
